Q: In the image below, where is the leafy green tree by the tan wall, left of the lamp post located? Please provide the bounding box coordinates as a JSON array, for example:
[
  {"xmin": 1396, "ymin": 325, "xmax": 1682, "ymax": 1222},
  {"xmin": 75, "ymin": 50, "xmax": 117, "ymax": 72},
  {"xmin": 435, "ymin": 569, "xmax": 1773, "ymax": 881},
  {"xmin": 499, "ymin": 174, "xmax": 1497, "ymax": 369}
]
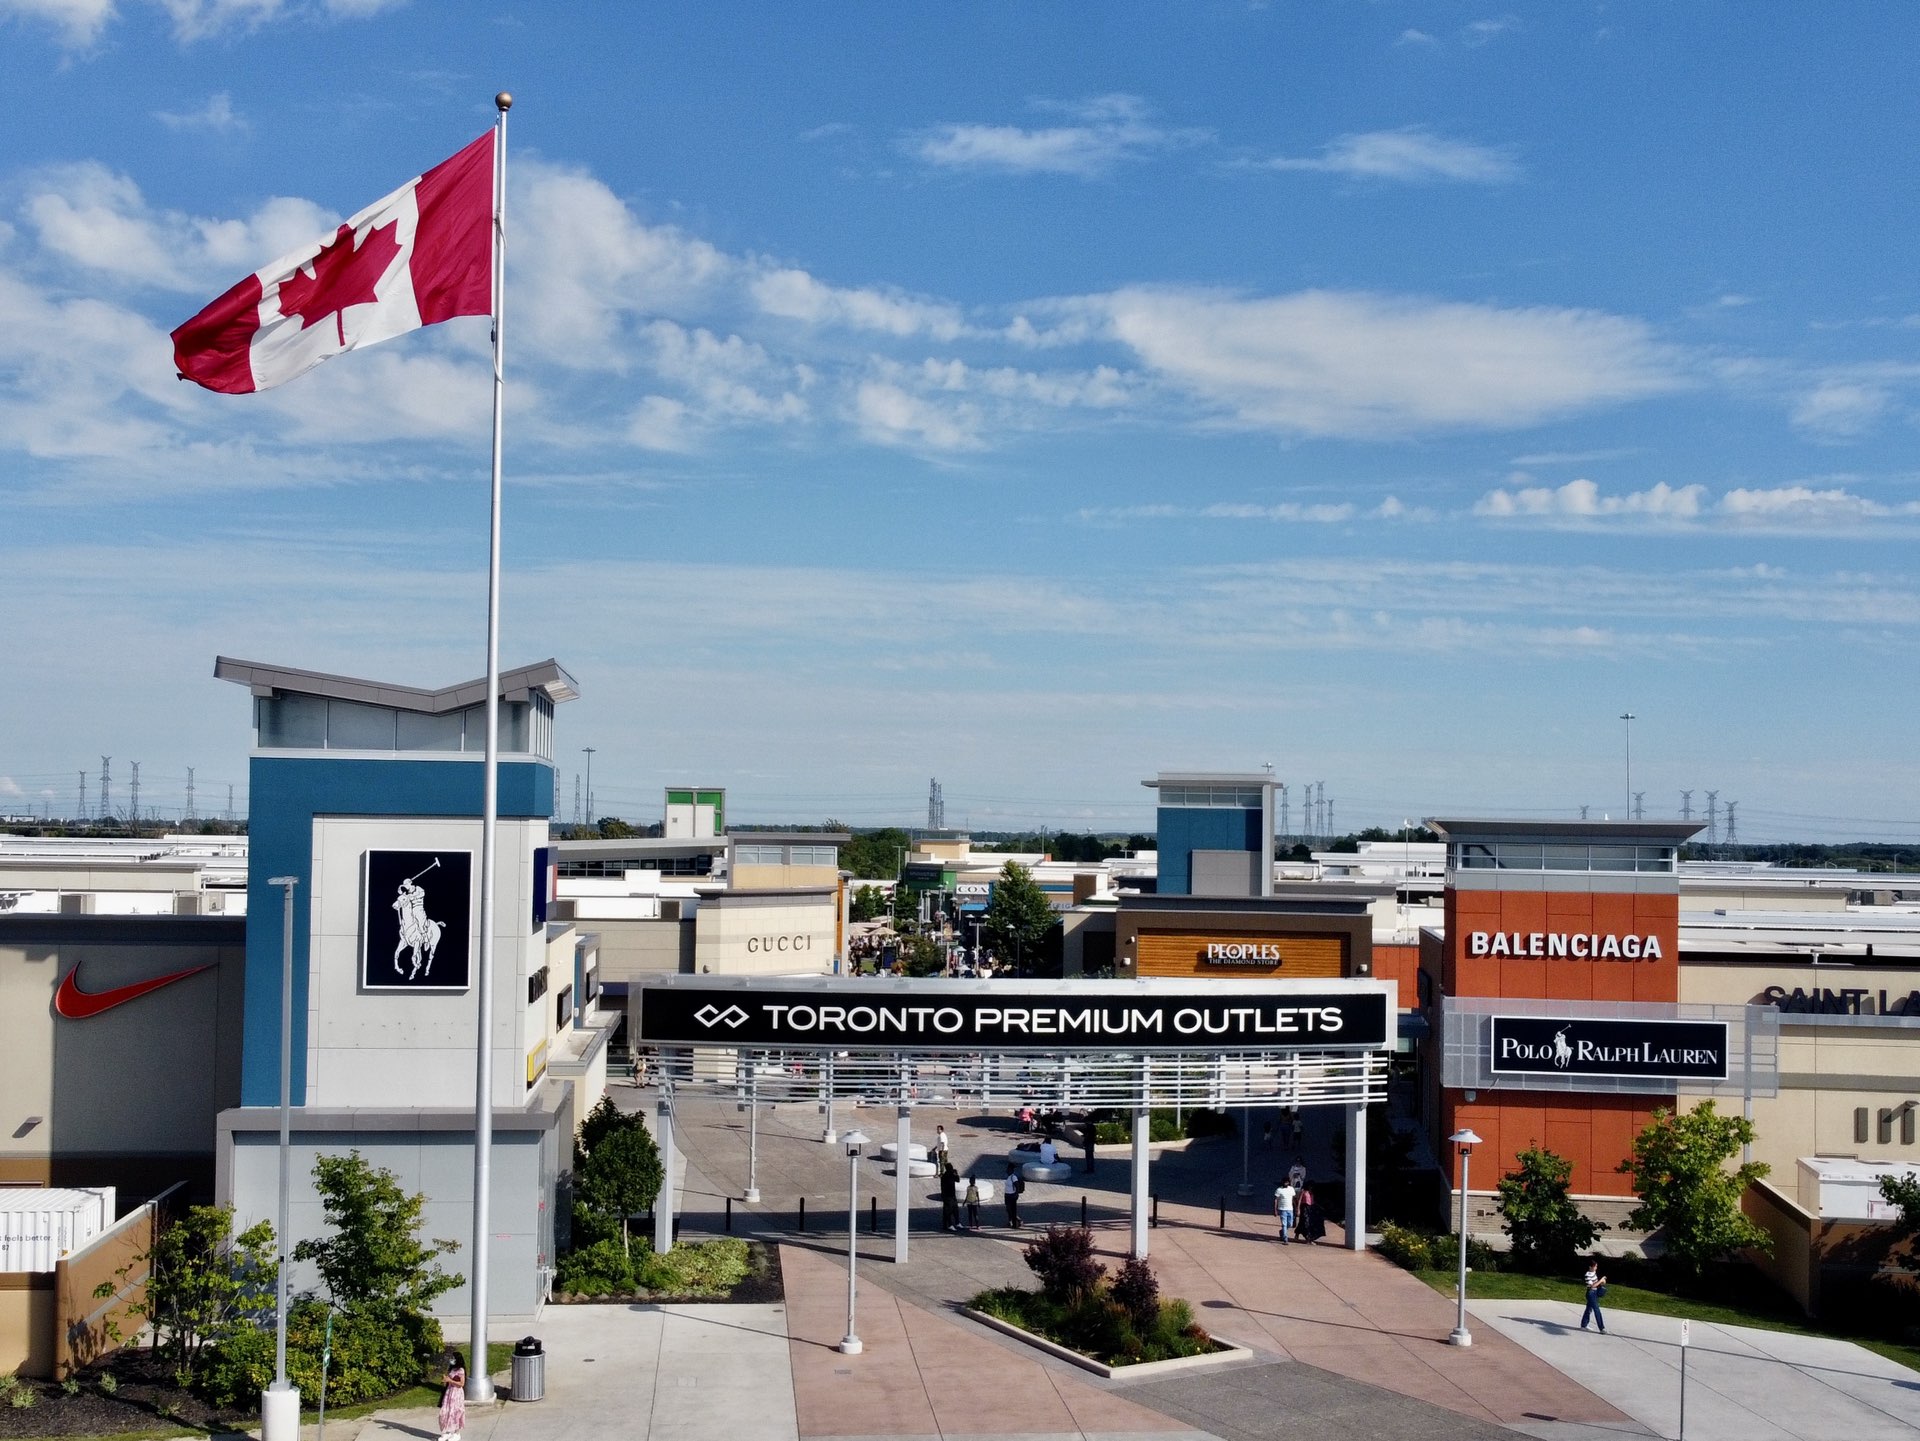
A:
[{"xmin": 94, "ymin": 1205, "xmax": 280, "ymax": 1387}]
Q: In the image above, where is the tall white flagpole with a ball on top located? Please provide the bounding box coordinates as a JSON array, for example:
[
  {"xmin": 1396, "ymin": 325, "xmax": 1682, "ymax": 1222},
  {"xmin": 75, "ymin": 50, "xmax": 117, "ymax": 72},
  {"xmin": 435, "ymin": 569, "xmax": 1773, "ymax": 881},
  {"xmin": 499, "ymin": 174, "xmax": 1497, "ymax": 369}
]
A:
[{"xmin": 467, "ymin": 90, "xmax": 513, "ymax": 1401}]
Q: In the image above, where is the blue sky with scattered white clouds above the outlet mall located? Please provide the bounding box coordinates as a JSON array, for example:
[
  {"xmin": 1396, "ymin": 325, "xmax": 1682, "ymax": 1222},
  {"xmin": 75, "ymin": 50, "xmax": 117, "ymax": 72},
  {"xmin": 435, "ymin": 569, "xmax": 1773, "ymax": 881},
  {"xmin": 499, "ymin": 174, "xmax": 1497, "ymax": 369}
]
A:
[{"xmin": 0, "ymin": 0, "xmax": 1920, "ymax": 840}]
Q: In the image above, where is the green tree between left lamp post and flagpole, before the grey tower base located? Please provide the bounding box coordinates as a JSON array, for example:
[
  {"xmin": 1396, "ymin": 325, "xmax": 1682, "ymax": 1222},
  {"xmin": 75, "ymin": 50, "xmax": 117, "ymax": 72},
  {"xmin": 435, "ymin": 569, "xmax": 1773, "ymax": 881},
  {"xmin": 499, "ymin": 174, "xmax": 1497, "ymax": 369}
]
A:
[{"xmin": 294, "ymin": 1151, "xmax": 467, "ymax": 1318}]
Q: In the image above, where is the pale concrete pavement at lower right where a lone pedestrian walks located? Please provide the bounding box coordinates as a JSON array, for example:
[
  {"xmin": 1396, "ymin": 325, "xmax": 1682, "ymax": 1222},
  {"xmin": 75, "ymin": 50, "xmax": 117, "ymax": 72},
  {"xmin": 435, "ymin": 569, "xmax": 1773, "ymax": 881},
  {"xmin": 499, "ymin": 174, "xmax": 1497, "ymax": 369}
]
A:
[{"xmin": 1467, "ymin": 1301, "xmax": 1920, "ymax": 1441}]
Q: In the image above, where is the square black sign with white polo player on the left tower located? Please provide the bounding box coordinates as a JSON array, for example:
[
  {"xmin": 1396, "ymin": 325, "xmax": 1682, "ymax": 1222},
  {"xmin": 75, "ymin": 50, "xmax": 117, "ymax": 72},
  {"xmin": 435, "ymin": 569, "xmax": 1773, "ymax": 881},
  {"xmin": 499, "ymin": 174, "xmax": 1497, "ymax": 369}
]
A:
[{"xmin": 361, "ymin": 850, "xmax": 474, "ymax": 990}]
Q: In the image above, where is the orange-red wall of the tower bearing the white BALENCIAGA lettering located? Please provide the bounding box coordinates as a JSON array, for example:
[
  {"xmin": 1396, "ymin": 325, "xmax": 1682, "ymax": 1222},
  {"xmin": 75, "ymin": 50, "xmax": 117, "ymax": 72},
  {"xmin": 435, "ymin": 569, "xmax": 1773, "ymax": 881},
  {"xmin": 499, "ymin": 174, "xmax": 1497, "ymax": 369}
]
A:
[{"xmin": 1440, "ymin": 886, "xmax": 1680, "ymax": 1195}]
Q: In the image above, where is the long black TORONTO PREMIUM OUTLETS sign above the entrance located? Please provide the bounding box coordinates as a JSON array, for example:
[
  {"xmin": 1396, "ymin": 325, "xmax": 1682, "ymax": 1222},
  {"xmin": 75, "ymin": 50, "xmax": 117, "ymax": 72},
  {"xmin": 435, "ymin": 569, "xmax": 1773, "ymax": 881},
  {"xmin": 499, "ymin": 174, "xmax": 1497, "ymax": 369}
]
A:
[{"xmin": 637, "ymin": 980, "xmax": 1390, "ymax": 1051}]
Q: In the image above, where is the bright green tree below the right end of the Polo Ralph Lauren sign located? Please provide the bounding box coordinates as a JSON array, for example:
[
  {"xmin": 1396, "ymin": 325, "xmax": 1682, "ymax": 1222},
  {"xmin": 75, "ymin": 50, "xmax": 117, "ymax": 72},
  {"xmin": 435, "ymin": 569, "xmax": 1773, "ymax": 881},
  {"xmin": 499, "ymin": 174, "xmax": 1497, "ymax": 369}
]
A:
[{"xmin": 1619, "ymin": 1101, "xmax": 1772, "ymax": 1276}]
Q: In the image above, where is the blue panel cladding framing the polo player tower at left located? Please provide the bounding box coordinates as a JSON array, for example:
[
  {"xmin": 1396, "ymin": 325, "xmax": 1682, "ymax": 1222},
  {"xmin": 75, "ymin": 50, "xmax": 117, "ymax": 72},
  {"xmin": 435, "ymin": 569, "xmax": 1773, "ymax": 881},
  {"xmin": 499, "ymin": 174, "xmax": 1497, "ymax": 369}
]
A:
[{"xmin": 240, "ymin": 756, "xmax": 553, "ymax": 1105}]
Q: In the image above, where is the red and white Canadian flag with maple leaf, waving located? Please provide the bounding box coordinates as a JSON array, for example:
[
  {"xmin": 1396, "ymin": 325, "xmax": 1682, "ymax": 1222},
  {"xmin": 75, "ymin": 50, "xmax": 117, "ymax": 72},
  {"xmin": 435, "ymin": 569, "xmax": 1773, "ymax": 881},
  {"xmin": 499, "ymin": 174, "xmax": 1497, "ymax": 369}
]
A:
[{"xmin": 173, "ymin": 130, "xmax": 493, "ymax": 395}]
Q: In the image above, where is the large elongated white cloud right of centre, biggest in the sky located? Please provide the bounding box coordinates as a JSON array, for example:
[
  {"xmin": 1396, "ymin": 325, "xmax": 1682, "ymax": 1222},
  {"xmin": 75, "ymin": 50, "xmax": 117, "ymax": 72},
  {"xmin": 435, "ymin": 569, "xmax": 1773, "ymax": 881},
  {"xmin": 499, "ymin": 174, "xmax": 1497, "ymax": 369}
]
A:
[{"xmin": 1085, "ymin": 288, "xmax": 1682, "ymax": 437}]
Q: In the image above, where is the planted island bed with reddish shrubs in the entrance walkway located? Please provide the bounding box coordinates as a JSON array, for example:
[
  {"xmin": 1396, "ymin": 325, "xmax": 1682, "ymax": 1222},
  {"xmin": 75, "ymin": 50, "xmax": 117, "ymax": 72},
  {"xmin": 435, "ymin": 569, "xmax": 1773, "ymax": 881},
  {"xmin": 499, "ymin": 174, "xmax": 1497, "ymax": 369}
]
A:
[{"xmin": 964, "ymin": 1226, "xmax": 1248, "ymax": 1376}]
